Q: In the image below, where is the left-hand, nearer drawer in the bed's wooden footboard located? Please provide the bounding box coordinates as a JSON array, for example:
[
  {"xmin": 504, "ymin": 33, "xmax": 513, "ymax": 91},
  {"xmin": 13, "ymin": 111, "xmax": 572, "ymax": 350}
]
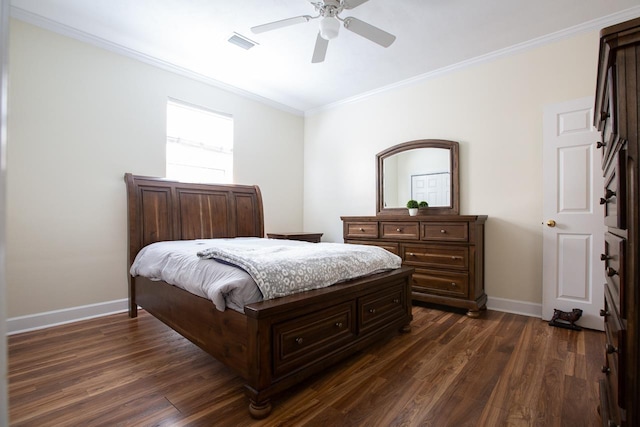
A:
[{"xmin": 273, "ymin": 301, "xmax": 357, "ymax": 376}]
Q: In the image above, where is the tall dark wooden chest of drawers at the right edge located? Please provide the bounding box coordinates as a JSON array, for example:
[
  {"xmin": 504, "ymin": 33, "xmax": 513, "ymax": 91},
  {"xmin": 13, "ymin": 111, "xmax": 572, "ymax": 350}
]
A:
[{"xmin": 594, "ymin": 19, "xmax": 640, "ymax": 427}]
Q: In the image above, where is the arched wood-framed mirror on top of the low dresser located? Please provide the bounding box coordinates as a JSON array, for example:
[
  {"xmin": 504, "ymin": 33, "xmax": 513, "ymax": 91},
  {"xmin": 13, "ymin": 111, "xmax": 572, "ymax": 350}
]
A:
[{"xmin": 376, "ymin": 139, "xmax": 460, "ymax": 215}]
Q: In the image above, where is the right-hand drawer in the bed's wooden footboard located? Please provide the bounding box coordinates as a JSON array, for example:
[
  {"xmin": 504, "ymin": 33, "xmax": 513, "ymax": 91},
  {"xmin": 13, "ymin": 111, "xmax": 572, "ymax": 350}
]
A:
[{"xmin": 358, "ymin": 284, "xmax": 408, "ymax": 334}]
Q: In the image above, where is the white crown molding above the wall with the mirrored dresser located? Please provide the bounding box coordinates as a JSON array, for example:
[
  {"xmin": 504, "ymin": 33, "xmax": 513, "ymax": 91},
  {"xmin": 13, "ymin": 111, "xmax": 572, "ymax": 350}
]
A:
[{"xmin": 305, "ymin": 6, "xmax": 640, "ymax": 116}]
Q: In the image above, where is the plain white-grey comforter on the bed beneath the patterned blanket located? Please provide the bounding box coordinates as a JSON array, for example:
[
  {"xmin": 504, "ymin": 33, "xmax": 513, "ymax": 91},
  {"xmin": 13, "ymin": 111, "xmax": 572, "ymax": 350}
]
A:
[{"xmin": 130, "ymin": 237, "xmax": 400, "ymax": 313}]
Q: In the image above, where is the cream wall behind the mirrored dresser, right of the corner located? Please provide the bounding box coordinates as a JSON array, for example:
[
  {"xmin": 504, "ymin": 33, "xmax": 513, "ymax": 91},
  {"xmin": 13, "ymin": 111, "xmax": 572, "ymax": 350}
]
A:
[{"xmin": 304, "ymin": 32, "xmax": 598, "ymax": 304}]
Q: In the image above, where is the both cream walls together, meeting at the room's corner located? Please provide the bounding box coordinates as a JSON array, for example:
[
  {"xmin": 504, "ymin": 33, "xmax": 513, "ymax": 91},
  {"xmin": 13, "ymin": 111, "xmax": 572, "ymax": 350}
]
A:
[{"xmin": 7, "ymin": 17, "xmax": 598, "ymax": 317}]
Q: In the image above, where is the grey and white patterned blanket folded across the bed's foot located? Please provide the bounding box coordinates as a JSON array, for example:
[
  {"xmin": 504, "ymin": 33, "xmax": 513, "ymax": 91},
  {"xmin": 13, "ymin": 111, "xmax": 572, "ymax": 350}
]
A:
[{"xmin": 198, "ymin": 243, "xmax": 401, "ymax": 299}]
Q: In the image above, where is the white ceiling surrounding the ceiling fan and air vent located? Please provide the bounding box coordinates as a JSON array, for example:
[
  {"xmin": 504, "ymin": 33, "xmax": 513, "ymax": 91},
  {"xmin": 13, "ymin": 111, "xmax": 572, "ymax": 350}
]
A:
[{"xmin": 11, "ymin": 0, "xmax": 640, "ymax": 113}]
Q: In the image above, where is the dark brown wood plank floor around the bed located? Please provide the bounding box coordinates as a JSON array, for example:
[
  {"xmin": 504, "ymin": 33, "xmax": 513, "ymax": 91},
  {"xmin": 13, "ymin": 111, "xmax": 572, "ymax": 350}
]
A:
[{"xmin": 9, "ymin": 307, "xmax": 604, "ymax": 427}]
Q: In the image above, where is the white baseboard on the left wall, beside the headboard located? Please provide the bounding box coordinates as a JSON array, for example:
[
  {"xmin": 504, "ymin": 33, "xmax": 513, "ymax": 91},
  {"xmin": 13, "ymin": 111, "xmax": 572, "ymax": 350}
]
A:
[{"xmin": 7, "ymin": 298, "xmax": 129, "ymax": 335}]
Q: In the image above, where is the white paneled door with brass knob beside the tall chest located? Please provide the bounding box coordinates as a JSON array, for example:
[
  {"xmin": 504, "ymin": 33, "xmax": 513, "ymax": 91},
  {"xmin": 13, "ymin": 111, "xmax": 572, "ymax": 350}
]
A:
[{"xmin": 542, "ymin": 97, "xmax": 606, "ymax": 330}]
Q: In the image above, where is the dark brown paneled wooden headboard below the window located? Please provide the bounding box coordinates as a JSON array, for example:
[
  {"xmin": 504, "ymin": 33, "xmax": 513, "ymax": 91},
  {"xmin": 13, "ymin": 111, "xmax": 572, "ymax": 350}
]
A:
[{"xmin": 124, "ymin": 173, "xmax": 264, "ymax": 265}]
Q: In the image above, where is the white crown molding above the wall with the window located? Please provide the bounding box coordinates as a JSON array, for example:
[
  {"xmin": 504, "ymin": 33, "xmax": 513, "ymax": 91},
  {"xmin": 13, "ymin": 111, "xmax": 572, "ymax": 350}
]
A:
[{"xmin": 11, "ymin": 6, "xmax": 304, "ymax": 116}]
